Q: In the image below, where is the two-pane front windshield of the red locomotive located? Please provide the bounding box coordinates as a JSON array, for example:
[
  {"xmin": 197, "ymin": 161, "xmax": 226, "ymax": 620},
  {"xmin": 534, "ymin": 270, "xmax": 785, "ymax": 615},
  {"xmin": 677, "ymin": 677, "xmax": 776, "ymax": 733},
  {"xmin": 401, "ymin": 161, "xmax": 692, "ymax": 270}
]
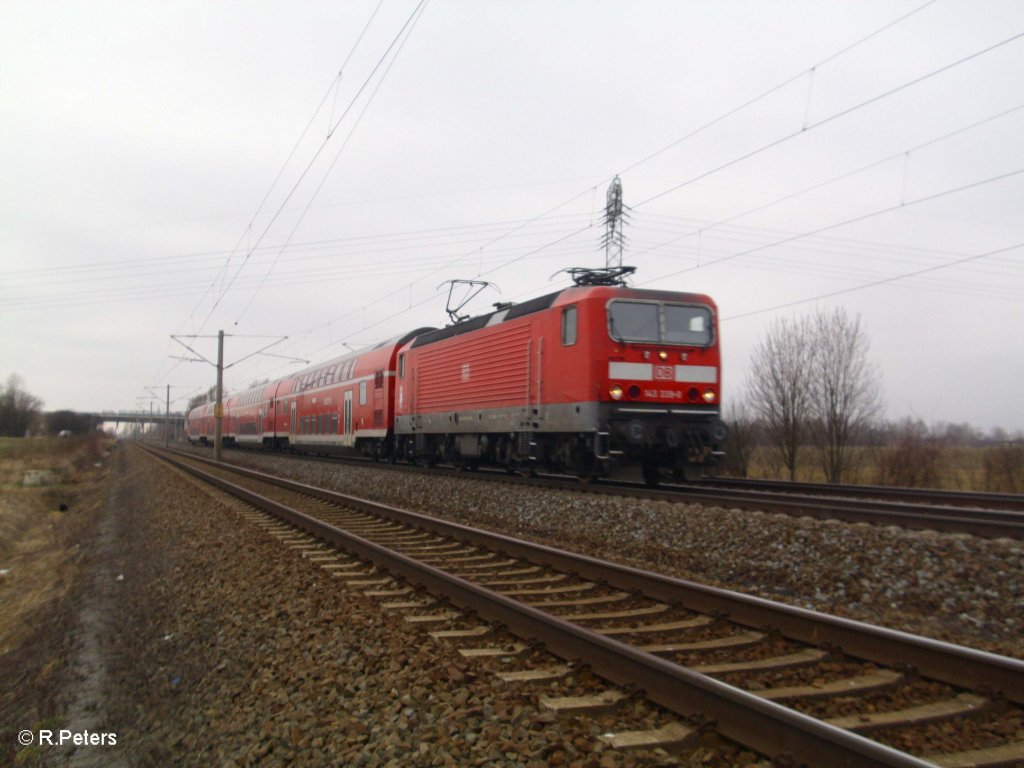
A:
[{"xmin": 608, "ymin": 301, "xmax": 712, "ymax": 346}]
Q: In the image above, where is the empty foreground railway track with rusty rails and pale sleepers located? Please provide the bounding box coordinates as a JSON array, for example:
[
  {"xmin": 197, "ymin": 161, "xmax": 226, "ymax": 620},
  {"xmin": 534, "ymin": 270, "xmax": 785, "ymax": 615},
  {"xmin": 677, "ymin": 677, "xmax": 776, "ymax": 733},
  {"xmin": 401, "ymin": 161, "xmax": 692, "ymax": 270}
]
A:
[{"xmin": 149, "ymin": 448, "xmax": 1024, "ymax": 767}]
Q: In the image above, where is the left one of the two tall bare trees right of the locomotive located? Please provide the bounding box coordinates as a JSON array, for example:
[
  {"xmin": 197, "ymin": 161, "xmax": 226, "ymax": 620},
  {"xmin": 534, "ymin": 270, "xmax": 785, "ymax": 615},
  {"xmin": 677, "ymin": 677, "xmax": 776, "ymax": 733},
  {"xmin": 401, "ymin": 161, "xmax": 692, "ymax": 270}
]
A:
[{"xmin": 746, "ymin": 317, "xmax": 814, "ymax": 480}]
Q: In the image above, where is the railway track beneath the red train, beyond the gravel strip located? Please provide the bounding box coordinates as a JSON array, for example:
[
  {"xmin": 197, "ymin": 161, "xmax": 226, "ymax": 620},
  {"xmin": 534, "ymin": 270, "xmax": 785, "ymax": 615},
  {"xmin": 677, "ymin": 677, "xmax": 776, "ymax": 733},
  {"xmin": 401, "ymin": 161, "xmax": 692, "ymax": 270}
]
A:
[{"xmin": 180, "ymin": 442, "xmax": 1024, "ymax": 539}]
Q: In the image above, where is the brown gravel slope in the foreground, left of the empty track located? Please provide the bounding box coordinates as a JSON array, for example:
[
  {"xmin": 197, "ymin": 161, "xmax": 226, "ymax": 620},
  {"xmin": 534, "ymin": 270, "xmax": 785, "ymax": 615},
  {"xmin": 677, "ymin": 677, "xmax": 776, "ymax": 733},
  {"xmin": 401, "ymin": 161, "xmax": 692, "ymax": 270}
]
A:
[{"xmin": 37, "ymin": 447, "xmax": 774, "ymax": 768}]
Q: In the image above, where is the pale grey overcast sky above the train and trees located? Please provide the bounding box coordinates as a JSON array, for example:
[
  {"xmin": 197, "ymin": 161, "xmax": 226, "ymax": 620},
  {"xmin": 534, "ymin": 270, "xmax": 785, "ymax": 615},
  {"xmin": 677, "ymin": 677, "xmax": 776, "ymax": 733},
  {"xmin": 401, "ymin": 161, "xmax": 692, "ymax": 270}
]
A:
[{"xmin": 0, "ymin": 0, "xmax": 1024, "ymax": 430}]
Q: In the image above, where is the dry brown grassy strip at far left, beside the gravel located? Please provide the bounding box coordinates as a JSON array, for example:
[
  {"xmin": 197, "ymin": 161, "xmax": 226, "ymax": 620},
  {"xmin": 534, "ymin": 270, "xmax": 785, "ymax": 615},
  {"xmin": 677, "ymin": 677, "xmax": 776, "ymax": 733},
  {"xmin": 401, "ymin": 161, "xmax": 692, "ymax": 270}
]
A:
[{"xmin": 0, "ymin": 435, "xmax": 114, "ymax": 766}]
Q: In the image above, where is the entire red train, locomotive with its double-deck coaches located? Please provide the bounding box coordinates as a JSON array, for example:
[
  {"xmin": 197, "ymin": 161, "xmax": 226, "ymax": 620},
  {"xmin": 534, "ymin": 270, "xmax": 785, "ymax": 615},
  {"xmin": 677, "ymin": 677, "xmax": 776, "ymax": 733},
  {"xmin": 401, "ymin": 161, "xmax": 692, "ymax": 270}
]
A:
[{"xmin": 187, "ymin": 267, "xmax": 728, "ymax": 484}]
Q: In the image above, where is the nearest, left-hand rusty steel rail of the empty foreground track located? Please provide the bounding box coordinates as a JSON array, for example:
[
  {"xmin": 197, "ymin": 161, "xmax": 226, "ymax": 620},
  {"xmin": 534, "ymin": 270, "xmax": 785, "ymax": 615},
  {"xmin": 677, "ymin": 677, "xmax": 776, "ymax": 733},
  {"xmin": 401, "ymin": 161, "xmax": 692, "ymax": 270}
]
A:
[{"xmin": 153, "ymin": 457, "xmax": 934, "ymax": 768}]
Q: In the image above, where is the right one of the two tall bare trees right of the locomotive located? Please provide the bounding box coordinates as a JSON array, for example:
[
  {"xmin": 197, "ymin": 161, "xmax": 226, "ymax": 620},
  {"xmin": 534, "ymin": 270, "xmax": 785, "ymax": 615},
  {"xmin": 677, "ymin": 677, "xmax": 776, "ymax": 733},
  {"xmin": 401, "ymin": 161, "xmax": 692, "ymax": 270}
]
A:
[{"xmin": 808, "ymin": 307, "xmax": 881, "ymax": 482}]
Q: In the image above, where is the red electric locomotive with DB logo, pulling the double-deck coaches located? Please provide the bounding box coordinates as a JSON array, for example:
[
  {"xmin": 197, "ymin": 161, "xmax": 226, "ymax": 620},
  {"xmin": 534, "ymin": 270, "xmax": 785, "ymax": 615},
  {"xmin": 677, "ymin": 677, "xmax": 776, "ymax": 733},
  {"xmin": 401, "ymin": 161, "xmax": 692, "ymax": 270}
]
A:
[{"xmin": 394, "ymin": 272, "xmax": 727, "ymax": 482}]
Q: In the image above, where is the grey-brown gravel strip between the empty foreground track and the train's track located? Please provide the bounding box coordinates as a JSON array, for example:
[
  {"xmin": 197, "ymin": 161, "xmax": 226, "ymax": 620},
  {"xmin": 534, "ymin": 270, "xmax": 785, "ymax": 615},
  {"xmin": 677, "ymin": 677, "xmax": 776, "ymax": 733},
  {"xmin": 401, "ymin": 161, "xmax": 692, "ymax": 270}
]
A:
[{"xmin": 216, "ymin": 452, "xmax": 1024, "ymax": 658}]
